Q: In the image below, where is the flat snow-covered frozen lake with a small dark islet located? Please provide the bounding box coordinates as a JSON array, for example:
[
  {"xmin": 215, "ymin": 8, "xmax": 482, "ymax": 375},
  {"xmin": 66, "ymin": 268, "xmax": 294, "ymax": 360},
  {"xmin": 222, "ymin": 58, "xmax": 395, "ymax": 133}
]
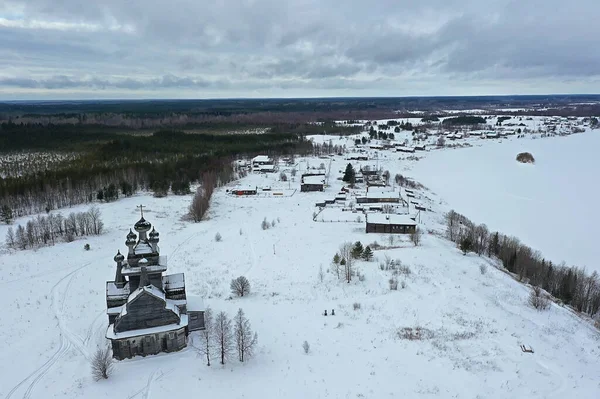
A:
[{"xmin": 412, "ymin": 131, "xmax": 600, "ymax": 272}]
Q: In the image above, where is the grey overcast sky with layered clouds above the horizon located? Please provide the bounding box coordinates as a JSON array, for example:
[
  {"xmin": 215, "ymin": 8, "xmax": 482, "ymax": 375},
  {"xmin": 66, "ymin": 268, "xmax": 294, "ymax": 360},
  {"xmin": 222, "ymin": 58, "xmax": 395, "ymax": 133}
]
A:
[{"xmin": 0, "ymin": 0, "xmax": 600, "ymax": 100}]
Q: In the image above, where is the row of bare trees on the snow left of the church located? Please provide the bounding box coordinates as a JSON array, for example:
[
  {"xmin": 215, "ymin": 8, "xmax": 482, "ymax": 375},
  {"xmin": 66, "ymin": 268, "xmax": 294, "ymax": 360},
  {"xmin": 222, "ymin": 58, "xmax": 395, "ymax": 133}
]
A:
[{"xmin": 6, "ymin": 207, "xmax": 104, "ymax": 249}]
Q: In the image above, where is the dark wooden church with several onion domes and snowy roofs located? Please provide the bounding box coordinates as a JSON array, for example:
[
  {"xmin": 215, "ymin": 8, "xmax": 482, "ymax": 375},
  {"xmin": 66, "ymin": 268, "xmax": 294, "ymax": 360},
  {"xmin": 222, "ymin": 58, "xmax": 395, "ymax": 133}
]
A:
[{"xmin": 106, "ymin": 207, "xmax": 204, "ymax": 360}]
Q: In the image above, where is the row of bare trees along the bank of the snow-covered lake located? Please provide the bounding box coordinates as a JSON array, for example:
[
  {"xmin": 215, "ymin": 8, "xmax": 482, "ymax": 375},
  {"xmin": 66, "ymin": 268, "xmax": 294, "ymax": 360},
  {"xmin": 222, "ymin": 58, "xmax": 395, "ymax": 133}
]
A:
[{"xmin": 446, "ymin": 211, "xmax": 600, "ymax": 316}]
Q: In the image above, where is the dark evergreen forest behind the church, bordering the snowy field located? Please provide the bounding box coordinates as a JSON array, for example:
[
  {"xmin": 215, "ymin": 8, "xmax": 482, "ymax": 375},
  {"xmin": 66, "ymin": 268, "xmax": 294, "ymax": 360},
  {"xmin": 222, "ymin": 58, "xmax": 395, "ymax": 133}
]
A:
[{"xmin": 0, "ymin": 123, "xmax": 316, "ymax": 219}]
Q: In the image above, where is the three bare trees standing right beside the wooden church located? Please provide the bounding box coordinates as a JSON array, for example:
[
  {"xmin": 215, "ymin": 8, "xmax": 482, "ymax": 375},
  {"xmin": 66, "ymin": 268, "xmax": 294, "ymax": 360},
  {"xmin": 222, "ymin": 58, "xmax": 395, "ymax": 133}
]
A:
[{"xmin": 197, "ymin": 308, "xmax": 258, "ymax": 366}]
